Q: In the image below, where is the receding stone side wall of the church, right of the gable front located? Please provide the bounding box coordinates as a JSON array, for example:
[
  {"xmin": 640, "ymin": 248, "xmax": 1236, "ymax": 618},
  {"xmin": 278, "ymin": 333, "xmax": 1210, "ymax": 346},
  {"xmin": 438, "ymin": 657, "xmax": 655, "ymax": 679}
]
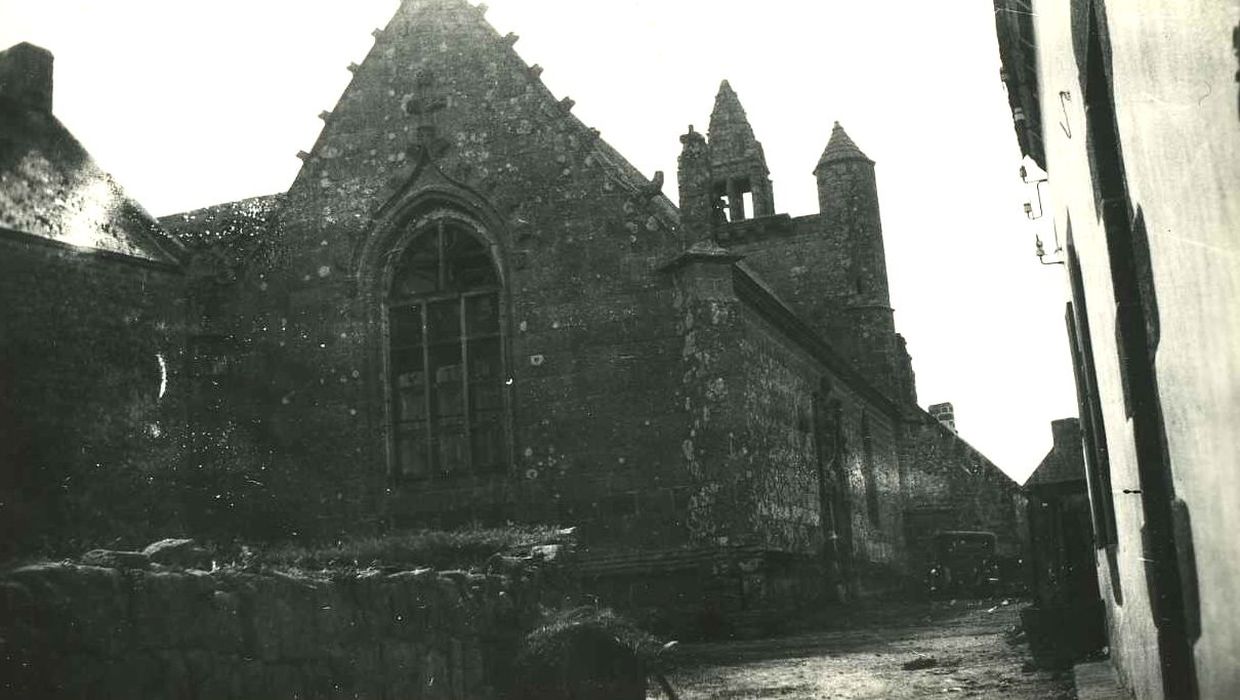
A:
[{"xmin": 677, "ymin": 247, "xmax": 901, "ymax": 566}]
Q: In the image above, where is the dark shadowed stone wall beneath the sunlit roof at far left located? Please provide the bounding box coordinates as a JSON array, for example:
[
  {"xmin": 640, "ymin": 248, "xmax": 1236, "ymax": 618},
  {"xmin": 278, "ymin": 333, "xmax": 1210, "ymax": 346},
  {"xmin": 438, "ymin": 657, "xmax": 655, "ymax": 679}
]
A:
[{"xmin": 0, "ymin": 229, "xmax": 191, "ymax": 555}]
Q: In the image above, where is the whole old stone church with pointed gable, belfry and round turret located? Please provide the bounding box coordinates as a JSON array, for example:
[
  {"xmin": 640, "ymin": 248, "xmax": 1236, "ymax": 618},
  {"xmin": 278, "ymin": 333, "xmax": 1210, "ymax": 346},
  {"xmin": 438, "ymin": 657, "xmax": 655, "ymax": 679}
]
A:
[{"xmin": 4, "ymin": 0, "xmax": 1021, "ymax": 615}]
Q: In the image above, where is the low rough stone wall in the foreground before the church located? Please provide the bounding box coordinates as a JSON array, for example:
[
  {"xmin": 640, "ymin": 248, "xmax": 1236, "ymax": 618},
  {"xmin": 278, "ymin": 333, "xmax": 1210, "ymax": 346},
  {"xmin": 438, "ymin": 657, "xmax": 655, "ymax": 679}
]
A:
[{"xmin": 0, "ymin": 562, "xmax": 537, "ymax": 699}]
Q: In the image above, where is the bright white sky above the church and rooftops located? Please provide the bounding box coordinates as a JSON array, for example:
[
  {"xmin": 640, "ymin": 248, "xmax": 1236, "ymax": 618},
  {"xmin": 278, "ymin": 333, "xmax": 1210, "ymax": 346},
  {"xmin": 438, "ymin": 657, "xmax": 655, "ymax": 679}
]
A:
[{"xmin": 0, "ymin": 0, "xmax": 1076, "ymax": 481}]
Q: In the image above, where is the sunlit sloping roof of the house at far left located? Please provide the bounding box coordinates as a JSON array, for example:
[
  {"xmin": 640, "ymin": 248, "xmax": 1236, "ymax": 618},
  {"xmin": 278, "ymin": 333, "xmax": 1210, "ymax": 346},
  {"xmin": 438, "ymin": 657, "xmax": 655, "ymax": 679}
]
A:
[{"xmin": 0, "ymin": 45, "xmax": 181, "ymax": 264}]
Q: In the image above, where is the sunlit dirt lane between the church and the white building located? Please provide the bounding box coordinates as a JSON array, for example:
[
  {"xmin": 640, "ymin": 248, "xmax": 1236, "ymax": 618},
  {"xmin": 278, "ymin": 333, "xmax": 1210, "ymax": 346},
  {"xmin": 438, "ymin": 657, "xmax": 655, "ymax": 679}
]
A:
[{"xmin": 650, "ymin": 601, "xmax": 1075, "ymax": 700}]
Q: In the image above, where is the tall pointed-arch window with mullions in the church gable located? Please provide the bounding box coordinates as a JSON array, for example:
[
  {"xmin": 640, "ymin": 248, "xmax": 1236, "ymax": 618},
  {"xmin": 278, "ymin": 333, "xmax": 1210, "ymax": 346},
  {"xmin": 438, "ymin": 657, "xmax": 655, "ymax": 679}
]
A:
[{"xmin": 387, "ymin": 217, "xmax": 507, "ymax": 481}]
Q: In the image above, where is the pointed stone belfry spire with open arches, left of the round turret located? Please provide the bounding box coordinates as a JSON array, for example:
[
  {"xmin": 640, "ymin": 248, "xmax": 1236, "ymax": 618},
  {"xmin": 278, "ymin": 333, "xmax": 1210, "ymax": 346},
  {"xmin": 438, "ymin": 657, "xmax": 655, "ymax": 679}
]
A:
[{"xmin": 707, "ymin": 81, "xmax": 775, "ymax": 222}]
